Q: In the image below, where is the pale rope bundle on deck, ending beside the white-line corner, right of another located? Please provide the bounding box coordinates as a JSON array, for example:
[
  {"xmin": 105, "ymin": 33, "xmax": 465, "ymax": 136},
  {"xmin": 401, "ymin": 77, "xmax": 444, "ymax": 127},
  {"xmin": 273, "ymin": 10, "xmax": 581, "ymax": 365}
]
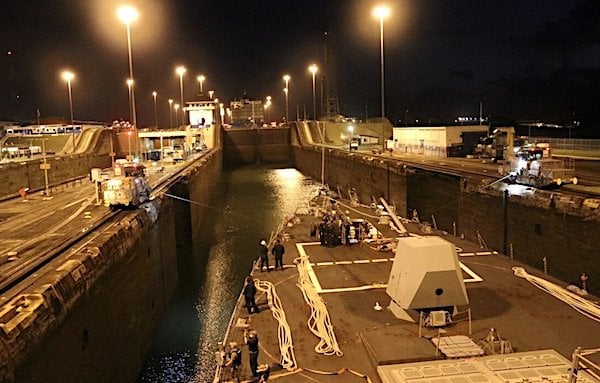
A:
[{"xmin": 294, "ymin": 256, "xmax": 344, "ymax": 356}]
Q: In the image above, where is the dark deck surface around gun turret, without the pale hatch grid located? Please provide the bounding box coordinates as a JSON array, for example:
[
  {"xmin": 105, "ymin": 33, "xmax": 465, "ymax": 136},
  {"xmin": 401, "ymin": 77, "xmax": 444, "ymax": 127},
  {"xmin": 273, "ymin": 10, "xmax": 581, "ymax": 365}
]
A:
[{"xmin": 221, "ymin": 196, "xmax": 600, "ymax": 383}]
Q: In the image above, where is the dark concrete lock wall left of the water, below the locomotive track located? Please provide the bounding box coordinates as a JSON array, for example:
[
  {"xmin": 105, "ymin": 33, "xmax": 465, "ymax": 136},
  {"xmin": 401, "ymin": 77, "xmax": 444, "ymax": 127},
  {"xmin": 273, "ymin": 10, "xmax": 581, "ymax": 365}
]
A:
[{"xmin": 0, "ymin": 150, "xmax": 222, "ymax": 382}]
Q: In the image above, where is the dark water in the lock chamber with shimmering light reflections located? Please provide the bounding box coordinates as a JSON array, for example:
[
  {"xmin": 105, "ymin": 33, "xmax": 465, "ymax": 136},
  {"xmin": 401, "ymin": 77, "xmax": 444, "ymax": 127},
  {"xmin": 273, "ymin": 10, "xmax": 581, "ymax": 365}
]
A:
[{"xmin": 138, "ymin": 166, "xmax": 316, "ymax": 383}]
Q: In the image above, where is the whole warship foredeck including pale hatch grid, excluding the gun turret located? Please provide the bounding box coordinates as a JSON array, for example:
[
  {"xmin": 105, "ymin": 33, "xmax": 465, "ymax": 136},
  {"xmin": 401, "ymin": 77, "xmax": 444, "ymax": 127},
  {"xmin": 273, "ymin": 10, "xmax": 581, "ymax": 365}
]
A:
[{"xmin": 215, "ymin": 196, "xmax": 600, "ymax": 383}]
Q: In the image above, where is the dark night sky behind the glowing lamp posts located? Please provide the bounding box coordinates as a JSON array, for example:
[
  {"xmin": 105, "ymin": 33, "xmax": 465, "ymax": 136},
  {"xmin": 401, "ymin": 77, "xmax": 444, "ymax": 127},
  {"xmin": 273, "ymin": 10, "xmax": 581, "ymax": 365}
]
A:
[{"xmin": 0, "ymin": 0, "xmax": 600, "ymax": 126}]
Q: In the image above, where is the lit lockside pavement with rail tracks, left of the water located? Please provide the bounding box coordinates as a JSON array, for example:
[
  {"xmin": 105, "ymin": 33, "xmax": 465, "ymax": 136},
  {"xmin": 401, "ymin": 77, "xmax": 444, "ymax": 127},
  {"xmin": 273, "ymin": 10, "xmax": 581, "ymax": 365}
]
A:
[{"xmin": 0, "ymin": 155, "xmax": 200, "ymax": 304}]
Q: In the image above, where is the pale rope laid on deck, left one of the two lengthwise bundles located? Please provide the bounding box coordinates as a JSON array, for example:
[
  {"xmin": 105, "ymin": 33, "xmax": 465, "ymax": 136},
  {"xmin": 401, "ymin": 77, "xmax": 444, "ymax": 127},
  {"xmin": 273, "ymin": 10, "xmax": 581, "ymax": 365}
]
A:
[{"xmin": 254, "ymin": 279, "xmax": 297, "ymax": 370}]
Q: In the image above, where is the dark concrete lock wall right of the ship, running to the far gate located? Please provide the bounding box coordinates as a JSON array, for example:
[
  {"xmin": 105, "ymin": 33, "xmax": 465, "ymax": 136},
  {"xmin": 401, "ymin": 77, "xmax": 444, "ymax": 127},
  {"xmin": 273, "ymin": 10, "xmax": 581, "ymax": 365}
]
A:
[{"xmin": 293, "ymin": 146, "xmax": 600, "ymax": 295}]
